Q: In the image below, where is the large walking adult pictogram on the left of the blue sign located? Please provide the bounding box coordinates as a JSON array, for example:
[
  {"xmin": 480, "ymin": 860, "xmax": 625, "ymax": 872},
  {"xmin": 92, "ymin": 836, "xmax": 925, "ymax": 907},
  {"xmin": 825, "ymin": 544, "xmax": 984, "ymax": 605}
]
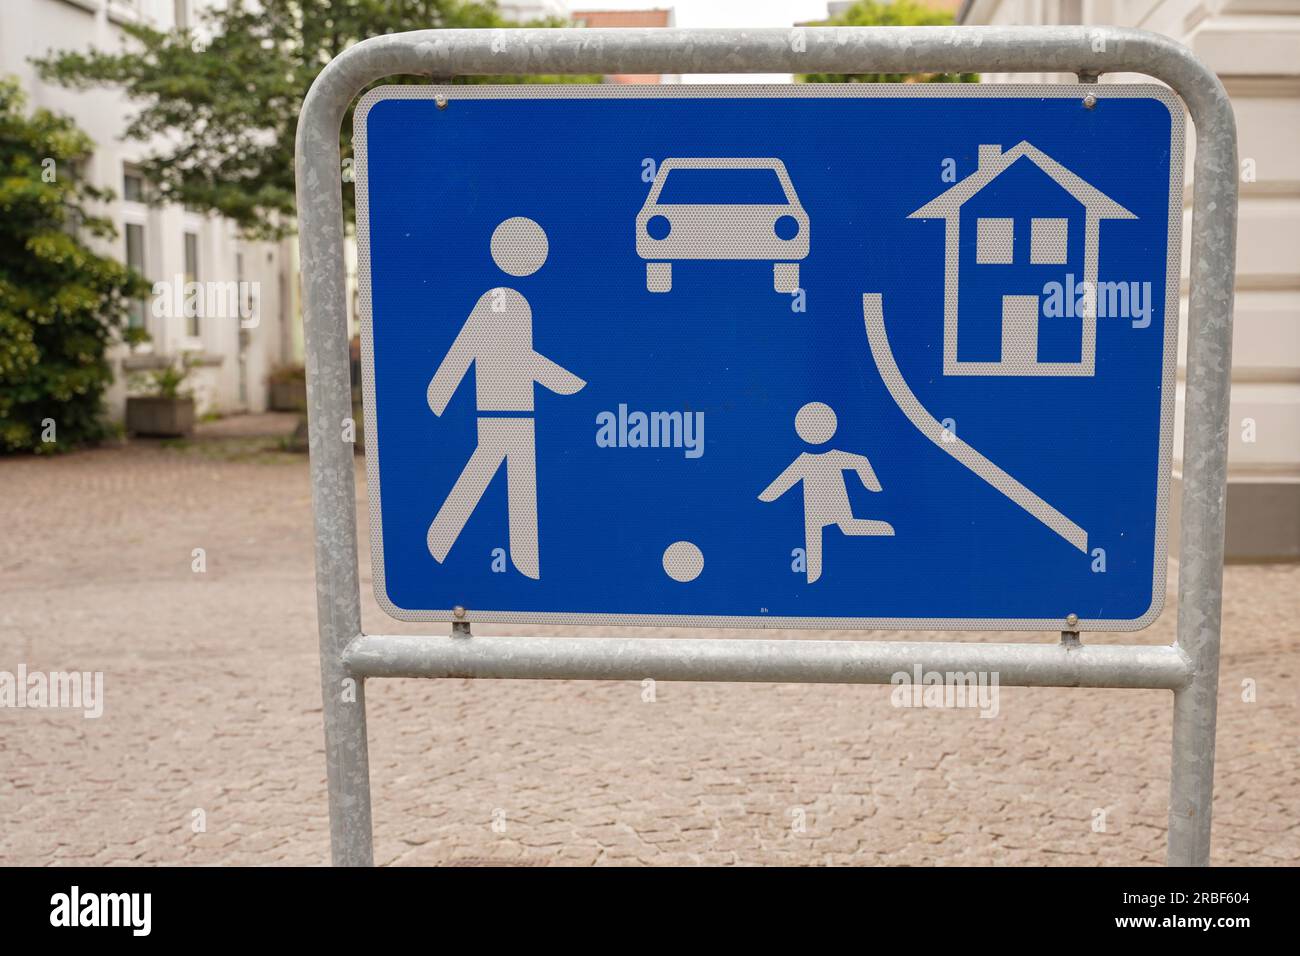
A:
[{"xmin": 428, "ymin": 216, "xmax": 586, "ymax": 579}]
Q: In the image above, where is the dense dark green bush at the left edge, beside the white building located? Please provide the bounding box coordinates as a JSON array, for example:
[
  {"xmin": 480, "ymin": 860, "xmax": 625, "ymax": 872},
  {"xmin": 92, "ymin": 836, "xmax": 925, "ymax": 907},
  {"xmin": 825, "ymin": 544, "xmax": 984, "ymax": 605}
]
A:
[{"xmin": 0, "ymin": 79, "xmax": 148, "ymax": 453}]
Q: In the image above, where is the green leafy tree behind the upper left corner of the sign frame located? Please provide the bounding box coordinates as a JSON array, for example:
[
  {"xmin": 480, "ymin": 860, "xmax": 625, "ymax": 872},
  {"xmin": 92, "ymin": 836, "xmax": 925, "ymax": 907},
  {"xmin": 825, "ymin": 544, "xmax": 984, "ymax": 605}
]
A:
[{"xmin": 35, "ymin": 0, "xmax": 599, "ymax": 238}]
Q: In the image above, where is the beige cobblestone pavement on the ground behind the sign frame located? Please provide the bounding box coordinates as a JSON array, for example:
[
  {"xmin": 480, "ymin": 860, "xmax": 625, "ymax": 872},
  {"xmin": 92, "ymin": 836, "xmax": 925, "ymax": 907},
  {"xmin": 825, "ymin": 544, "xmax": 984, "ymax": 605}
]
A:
[{"xmin": 0, "ymin": 442, "xmax": 1300, "ymax": 865}]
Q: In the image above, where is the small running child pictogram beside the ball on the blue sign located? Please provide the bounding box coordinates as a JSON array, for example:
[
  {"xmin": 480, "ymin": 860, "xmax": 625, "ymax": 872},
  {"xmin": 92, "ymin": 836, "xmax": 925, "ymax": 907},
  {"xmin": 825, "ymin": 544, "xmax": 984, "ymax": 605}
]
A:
[{"xmin": 758, "ymin": 402, "xmax": 894, "ymax": 584}]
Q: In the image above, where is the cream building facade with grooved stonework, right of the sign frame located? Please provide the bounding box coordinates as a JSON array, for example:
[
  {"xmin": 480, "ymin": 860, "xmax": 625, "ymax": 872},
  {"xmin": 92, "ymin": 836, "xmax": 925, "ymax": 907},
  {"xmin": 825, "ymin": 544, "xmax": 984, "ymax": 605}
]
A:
[{"xmin": 958, "ymin": 0, "xmax": 1300, "ymax": 559}]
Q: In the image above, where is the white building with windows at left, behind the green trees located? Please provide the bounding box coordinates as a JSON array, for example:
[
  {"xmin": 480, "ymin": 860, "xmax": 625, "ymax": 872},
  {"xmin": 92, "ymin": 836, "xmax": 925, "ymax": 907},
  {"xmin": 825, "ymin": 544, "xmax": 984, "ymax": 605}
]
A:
[{"xmin": 0, "ymin": 0, "xmax": 302, "ymax": 419}]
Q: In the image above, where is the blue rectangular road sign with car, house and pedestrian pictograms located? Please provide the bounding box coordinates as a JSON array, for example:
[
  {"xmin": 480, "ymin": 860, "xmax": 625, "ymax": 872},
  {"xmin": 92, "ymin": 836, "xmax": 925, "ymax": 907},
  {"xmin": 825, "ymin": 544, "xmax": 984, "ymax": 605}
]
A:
[{"xmin": 354, "ymin": 85, "xmax": 1183, "ymax": 630}]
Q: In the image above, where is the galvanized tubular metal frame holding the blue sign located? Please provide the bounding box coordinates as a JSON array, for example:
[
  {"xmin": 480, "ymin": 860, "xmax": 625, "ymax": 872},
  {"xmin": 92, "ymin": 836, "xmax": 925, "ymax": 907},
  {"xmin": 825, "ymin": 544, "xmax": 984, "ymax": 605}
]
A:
[{"xmin": 295, "ymin": 26, "xmax": 1238, "ymax": 865}]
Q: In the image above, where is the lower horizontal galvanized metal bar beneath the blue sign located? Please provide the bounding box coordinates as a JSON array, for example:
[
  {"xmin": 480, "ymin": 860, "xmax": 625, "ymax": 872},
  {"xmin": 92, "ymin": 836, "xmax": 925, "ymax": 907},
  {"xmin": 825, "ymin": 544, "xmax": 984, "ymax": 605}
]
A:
[{"xmin": 343, "ymin": 635, "xmax": 1191, "ymax": 691}]
